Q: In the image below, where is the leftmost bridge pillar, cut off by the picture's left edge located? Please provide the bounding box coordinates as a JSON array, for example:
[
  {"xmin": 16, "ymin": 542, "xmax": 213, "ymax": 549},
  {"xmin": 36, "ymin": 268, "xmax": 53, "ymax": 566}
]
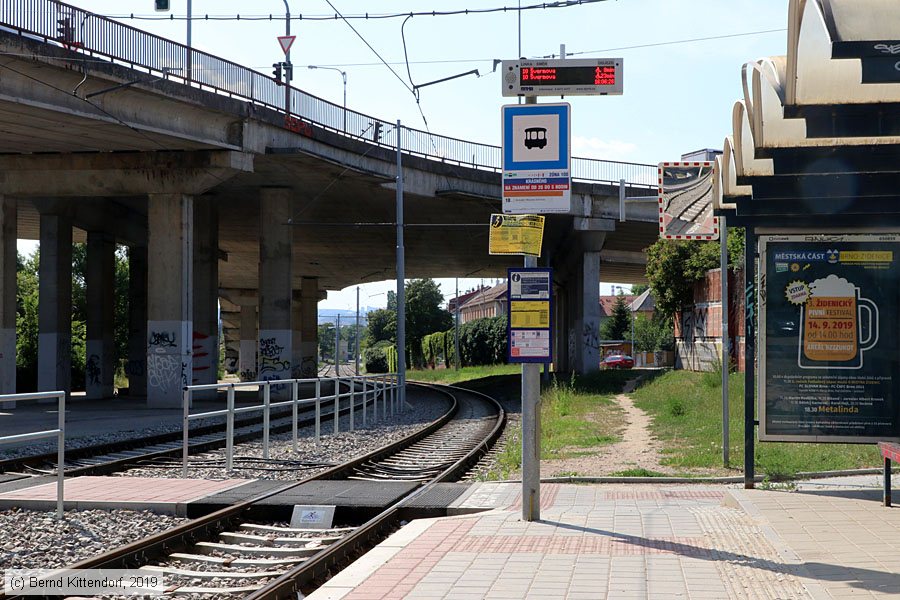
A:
[{"xmin": 0, "ymin": 195, "xmax": 17, "ymax": 408}]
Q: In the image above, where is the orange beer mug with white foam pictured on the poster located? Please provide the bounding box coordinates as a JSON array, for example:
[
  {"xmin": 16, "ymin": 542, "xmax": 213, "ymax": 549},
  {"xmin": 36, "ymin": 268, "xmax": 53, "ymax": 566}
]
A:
[{"xmin": 797, "ymin": 275, "xmax": 878, "ymax": 369}]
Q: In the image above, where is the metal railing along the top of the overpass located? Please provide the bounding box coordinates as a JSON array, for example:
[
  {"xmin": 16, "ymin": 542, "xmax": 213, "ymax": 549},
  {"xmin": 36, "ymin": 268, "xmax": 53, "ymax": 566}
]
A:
[{"xmin": 0, "ymin": 0, "xmax": 657, "ymax": 188}]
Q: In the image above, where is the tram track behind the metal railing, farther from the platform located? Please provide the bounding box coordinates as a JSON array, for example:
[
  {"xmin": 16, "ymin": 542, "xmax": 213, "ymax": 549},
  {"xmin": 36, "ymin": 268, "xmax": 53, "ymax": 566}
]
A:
[{"xmin": 0, "ymin": 380, "xmax": 370, "ymax": 477}]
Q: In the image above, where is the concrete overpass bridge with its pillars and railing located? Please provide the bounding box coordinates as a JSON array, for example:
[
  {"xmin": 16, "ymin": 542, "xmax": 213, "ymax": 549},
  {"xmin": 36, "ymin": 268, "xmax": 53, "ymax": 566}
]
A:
[{"xmin": 0, "ymin": 0, "xmax": 657, "ymax": 406}]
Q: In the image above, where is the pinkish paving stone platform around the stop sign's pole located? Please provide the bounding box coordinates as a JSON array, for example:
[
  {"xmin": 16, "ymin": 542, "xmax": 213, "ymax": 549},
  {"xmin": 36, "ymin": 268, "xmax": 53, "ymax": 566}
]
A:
[{"xmin": 309, "ymin": 484, "xmax": 884, "ymax": 600}]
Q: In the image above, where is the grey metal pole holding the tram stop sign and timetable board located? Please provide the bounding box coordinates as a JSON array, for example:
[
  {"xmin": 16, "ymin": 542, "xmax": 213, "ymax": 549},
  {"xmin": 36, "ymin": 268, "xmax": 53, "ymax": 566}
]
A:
[{"xmin": 522, "ymin": 96, "xmax": 541, "ymax": 521}]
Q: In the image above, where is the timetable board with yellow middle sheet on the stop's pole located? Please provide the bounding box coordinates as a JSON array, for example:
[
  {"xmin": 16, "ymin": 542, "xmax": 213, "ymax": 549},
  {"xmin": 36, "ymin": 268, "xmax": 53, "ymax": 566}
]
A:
[{"xmin": 506, "ymin": 268, "xmax": 553, "ymax": 363}]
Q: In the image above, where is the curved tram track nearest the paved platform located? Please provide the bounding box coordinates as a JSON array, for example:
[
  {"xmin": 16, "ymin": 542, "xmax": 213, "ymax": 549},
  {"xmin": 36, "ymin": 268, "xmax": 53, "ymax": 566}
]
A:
[{"xmin": 1, "ymin": 384, "xmax": 506, "ymax": 599}]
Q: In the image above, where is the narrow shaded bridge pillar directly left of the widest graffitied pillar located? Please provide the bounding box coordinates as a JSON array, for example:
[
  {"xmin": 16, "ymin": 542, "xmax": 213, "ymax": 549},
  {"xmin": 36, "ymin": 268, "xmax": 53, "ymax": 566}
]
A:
[{"xmin": 125, "ymin": 245, "xmax": 147, "ymax": 398}]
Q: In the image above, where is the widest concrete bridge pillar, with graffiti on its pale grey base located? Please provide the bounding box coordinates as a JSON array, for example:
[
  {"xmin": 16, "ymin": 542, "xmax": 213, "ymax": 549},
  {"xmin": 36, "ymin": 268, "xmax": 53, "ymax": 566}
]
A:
[{"xmin": 147, "ymin": 194, "xmax": 194, "ymax": 408}]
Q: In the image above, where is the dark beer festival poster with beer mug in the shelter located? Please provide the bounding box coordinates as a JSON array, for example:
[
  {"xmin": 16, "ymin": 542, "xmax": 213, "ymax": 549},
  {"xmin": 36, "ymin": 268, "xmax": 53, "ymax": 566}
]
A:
[{"xmin": 759, "ymin": 234, "xmax": 900, "ymax": 443}]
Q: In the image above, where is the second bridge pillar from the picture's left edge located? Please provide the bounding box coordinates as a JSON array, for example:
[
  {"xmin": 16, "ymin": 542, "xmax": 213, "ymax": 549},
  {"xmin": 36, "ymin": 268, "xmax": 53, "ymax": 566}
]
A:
[{"xmin": 38, "ymin": 213, "xmax": 72, "ymax": 394}]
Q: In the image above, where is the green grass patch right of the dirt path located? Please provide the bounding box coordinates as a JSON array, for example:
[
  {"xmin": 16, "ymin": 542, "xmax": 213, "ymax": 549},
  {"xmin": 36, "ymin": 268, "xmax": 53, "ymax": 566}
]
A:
[{"xmin": 632, "ymin": 371, "xmax": 881, "ymax": 480}]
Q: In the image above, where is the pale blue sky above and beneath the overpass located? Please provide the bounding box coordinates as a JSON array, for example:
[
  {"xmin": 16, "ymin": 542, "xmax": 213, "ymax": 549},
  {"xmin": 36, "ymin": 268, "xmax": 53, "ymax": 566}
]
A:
[{"xmin": 35, "ymin": 0, "xmax": 788, "ymax": 308}]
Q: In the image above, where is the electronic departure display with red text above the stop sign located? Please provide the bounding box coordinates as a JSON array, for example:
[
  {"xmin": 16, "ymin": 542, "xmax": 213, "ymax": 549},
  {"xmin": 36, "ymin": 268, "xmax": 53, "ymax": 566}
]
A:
[{"xmin": 503, "ymin": 58, "xmax": 622, "ymax": 96}]
